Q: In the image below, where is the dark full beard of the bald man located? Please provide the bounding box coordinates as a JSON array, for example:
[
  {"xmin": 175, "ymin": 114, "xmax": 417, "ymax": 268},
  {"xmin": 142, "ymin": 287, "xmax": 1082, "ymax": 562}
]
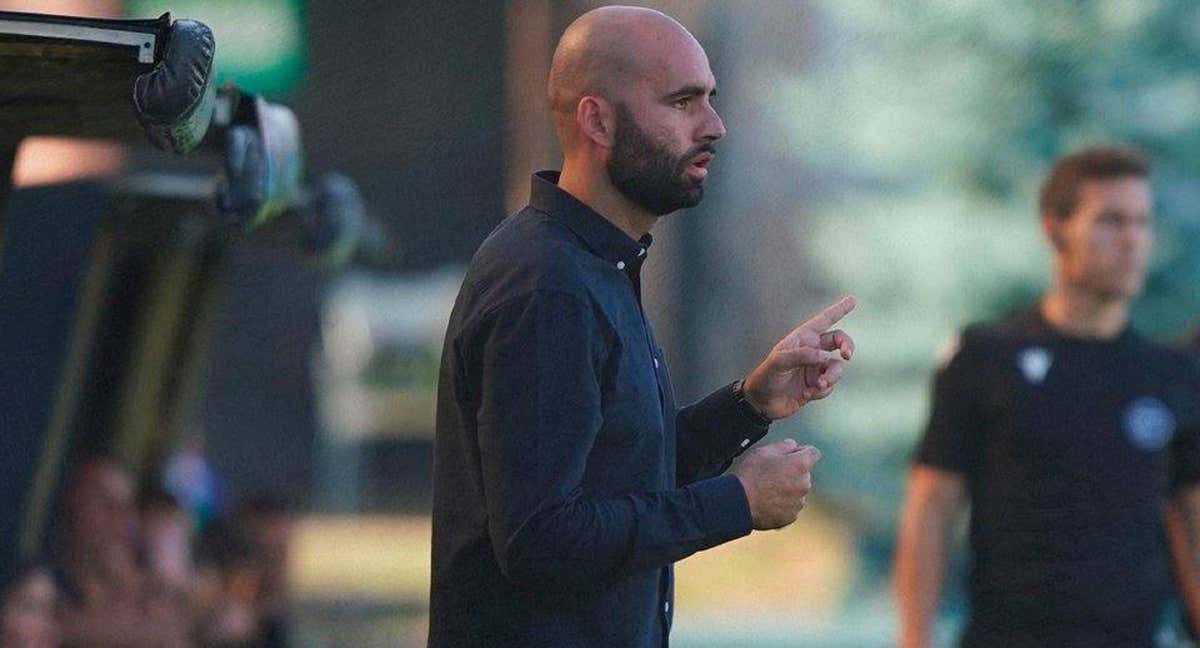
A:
[{"xmin": 606, "ymin": 103, "xmax": 716, "ymax": 216}]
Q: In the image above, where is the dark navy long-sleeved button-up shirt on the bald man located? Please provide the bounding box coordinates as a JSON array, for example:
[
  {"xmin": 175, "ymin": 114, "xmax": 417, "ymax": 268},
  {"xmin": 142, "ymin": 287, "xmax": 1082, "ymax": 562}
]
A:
[{"xmin": 430, "ymin": 172, "xmax": 767, "ymax": 648}]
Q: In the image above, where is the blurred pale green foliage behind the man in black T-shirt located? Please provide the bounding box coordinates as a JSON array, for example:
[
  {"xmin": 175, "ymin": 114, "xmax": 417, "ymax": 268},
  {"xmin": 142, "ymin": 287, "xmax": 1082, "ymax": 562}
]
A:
[{"xmin": 756, "ymin": 0, "xmax": 1200, "ymax": 501}]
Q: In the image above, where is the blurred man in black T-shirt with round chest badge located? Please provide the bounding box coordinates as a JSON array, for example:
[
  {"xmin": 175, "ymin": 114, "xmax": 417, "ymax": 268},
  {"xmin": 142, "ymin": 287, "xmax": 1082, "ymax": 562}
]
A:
[{"xmin": 896, "ymin": 148, "xmax": 1200, "ymax": 648}]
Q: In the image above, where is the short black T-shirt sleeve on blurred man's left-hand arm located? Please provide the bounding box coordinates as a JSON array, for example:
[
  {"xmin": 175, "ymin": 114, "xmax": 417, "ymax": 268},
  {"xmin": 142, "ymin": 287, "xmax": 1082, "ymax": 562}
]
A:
[{"xmin": 913, "ymin": 336, "xmax": 980, "ymax": 474}]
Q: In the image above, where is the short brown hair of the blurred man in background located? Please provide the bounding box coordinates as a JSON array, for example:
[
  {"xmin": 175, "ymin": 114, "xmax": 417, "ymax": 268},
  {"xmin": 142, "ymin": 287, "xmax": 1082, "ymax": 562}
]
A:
[{"xmin": 1038, "ymin": 146, "xmax": 1150, "ymax": 220}]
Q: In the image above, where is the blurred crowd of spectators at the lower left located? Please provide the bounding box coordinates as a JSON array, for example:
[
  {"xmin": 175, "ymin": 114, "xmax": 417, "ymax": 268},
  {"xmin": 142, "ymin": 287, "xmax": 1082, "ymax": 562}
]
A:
[{"xmin": 0, "ymin": 457, "xmax": 290, "ymax": 648}]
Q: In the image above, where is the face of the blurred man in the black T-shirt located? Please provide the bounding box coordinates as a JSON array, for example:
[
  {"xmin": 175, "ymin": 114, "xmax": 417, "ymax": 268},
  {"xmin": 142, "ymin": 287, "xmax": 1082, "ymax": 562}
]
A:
[{"xmin": 1049, "ymin": 176, "xmax": 1154, "ymax": 299}]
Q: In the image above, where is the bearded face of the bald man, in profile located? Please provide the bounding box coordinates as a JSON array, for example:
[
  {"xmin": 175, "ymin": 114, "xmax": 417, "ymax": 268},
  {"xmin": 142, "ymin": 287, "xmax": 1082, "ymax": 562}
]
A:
[{"xmin": 607, "ymin": 29, "xmax": 725, "ymax": 215}]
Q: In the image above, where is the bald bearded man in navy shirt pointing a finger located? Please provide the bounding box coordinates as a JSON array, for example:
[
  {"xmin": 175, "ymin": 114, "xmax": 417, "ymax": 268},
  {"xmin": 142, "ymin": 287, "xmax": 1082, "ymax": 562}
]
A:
[{"xmin": 430, "ymin": 7, "xmax": 854, "ymax": 648}]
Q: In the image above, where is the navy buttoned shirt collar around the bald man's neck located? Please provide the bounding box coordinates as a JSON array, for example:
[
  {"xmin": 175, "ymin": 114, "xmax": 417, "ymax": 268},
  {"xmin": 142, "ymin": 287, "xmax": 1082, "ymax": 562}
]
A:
[{"xmin": 529, "ymin": 170, "xmax": 654, "ymax": 276}]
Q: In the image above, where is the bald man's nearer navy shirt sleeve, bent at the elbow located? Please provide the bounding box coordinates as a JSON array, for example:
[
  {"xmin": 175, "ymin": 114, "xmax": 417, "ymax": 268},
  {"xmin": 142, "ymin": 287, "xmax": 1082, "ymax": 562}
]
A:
[{"xmin": 468, "ymin": 292, "xmax": 751, "ymax": 588}]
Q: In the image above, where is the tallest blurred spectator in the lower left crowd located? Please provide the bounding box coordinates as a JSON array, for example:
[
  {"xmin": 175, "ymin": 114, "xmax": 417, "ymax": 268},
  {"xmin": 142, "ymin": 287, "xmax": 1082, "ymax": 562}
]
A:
[{"xmin": 58, "ymin": 457, "xmax": 192, "ymax": 648}]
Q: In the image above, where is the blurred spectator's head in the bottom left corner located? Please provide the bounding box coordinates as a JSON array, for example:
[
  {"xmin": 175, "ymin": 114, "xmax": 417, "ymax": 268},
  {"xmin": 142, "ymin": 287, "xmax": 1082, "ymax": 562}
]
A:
[{"xmin": 0, "ymin": 563, "xmax": 60, "ymax": 648}]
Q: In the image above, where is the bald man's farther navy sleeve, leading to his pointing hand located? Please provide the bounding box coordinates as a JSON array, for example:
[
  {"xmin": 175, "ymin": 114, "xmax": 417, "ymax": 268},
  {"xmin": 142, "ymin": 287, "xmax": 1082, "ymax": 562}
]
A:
[{"xmin": 676, "ymin": 383, "xmax": 769, "ymax": 484}]
